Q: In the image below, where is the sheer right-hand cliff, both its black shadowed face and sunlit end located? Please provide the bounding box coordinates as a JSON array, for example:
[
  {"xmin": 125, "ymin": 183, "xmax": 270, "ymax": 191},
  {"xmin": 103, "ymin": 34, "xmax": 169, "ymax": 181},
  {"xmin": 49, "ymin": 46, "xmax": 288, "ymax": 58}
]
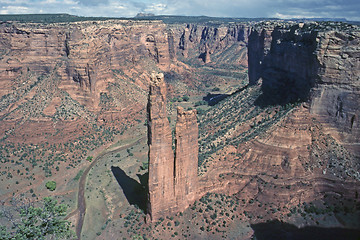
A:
[{"xmin": 248, "ymin": 25, "xmax": 360, "ymax": 156}]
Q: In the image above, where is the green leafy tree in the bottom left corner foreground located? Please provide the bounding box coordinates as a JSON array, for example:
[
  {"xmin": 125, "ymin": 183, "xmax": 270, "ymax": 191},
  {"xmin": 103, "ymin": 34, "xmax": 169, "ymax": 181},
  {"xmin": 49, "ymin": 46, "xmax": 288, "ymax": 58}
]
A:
[{"xmin": 0, "ymin": 197, "xmax": 75, "ymax": 240}]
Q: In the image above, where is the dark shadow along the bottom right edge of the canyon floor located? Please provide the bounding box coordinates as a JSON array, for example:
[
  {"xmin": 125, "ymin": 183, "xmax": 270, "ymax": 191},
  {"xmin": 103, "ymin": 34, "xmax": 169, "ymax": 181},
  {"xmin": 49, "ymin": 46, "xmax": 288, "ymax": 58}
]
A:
[{"xmin": 251, "ymin": 220, "xmax": 360, "ymax": 240}]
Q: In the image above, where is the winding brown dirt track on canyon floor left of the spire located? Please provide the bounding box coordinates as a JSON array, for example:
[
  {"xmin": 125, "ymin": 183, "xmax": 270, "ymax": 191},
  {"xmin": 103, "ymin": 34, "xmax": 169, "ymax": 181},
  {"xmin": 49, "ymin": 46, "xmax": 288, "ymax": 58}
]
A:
[{"xmin": 65, "ymin": 137, "xmax": 146, "ymax": 240}]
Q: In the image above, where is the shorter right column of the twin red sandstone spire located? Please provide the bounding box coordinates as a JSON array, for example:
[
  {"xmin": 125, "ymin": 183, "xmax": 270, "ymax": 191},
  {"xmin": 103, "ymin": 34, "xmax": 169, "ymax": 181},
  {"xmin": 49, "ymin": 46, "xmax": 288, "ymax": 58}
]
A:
[{"xmin": 175, "ymin": 107, "xmax": 199, "ymax": 211}]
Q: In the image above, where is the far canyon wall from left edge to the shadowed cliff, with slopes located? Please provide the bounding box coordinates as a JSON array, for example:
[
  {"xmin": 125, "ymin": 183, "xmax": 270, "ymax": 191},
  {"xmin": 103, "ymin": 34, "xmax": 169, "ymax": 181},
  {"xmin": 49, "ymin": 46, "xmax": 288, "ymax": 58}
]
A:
[{"xmin": 0, "ymin": 20, "xmax": 248, "ymax": 141}]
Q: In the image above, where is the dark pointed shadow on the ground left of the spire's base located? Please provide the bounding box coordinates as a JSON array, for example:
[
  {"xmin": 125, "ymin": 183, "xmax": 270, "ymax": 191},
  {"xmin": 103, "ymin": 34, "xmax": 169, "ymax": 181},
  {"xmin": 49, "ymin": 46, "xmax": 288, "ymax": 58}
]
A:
[{"xmin": 111, "ymin": 167, "xmax": 148, "ymax": 212}]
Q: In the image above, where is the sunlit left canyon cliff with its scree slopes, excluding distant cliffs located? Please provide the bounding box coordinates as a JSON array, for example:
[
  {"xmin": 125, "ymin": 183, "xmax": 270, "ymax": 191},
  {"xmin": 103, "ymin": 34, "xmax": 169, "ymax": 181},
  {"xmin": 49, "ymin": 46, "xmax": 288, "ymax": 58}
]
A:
[{"xmin": 0, "ymin": 21, "xmax": 171, "ymax": 131}]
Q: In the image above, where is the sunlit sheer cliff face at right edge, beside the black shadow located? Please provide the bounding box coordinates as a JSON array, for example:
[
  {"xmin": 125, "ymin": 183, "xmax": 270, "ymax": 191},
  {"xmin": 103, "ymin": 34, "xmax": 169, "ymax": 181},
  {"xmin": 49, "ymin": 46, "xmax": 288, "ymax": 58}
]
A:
[{"xmin": 310, "ymin": 28, "xmax": 360, "ymax": 152}]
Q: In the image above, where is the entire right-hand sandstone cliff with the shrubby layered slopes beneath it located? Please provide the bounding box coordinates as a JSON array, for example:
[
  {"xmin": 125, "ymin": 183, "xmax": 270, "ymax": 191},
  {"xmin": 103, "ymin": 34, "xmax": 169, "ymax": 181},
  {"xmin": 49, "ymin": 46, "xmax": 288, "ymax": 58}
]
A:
[{"xmin": 193, "ymin": 22, "xmax": 360, "ymax": 224}]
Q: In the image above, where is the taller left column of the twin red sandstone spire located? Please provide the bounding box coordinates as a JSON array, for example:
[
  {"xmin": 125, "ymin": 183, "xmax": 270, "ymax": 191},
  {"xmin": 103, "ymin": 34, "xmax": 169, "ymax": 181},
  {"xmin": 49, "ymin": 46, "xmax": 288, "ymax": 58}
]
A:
[{"xmin": 148, "ymin": 73, "xmax": 175, "ymax": 220}]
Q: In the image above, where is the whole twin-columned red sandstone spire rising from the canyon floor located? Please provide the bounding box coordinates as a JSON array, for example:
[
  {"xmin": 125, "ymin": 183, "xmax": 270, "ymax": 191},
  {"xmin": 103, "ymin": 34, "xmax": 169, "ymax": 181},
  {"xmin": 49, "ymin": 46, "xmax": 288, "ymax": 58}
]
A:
[{"xmin": 147, "ymin": 73, "xmax": 198, "ymax": 220}]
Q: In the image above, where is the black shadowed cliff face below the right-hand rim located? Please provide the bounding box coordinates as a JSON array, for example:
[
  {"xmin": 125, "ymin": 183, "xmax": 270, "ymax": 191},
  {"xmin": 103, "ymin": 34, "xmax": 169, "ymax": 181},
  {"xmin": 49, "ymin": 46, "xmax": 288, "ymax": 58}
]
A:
[{"xmin": 248, "ymin": 24, "xmax": 319, "ymax": 103}]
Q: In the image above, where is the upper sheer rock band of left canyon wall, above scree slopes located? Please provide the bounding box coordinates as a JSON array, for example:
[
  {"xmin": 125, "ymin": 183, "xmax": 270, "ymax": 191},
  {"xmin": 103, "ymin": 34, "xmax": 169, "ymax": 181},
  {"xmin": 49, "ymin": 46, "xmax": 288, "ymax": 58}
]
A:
[{"xmin": 0, "ymin": 21, "xmax": 169, "ymax": 111}]
